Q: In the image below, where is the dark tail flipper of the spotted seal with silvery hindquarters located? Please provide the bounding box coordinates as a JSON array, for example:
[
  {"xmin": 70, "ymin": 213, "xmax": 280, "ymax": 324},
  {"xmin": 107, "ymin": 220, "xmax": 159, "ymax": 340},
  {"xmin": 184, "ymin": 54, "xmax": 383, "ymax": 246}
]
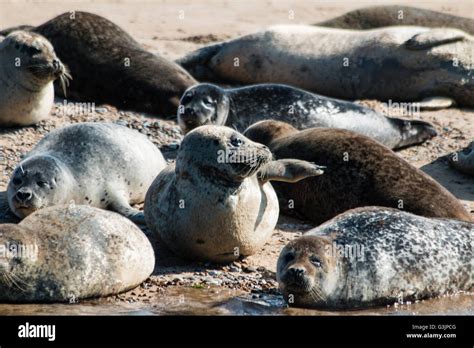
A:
[{"xmin": 390, "ymin": 118, "xmax": 438, "ymax": 149}]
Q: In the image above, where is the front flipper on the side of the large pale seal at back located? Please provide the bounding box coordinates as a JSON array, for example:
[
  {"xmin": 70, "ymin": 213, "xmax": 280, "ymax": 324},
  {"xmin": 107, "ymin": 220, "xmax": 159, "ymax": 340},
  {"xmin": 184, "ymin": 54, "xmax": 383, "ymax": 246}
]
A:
[{"xmin": 405, "ymin": 28, "xmax": 469, "ymax": 51}]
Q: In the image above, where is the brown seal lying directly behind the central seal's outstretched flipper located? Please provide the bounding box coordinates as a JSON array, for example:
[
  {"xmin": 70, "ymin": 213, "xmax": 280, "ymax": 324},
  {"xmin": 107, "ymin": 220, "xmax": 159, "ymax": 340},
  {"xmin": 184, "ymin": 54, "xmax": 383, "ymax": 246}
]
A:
[{"xmin": 244, "ymin": 121, "xmax": 471, "ymax": 224}]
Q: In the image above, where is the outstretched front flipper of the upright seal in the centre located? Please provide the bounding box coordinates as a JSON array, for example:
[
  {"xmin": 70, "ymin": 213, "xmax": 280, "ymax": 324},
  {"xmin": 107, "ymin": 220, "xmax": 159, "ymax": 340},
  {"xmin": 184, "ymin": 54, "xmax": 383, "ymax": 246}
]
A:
[{"xmin": 257, "ymin": 159, "xmax": 326, "ymax": 183}]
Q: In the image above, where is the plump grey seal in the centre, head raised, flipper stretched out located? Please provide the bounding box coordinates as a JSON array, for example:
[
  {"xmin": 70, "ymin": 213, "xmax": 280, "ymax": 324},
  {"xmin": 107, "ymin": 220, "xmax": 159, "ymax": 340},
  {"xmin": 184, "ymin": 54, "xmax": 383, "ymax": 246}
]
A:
[{"xmin": 145, "ymin": 126, "xmax": 322, "ymax": 263}]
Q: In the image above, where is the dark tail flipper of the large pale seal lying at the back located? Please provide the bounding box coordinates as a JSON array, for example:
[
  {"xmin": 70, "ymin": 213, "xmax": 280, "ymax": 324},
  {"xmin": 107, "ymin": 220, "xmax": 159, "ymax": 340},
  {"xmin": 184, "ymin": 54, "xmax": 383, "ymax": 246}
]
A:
[{"xmin": 175, "ymin": 43, "xmax": 224, "ymax": 81}]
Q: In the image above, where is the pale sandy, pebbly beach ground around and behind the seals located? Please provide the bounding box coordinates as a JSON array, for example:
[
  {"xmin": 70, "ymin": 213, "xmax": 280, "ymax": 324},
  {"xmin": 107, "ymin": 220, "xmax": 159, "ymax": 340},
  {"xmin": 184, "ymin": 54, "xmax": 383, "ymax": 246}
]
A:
[{"xmin": 0, "ymin": 0, "xmax": 474, "ymax": 314}]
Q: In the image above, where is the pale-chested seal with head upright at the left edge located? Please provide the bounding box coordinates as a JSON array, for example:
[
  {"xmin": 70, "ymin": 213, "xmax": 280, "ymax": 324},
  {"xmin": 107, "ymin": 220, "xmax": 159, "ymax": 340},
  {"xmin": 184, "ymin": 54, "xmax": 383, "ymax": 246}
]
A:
[{"xmin": 0, "ymin": 31, "xmax": 70, "ymax": 127}]
